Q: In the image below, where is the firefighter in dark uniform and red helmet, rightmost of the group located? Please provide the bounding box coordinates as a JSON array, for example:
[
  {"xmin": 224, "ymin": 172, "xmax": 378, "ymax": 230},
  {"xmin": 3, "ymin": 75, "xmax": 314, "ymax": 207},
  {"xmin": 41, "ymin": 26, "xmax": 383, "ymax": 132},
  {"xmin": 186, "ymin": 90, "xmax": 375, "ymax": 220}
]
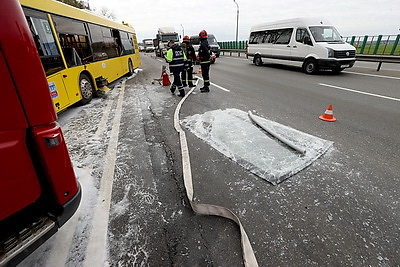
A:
[{"xmin": 199, "ymin": 30, "xmax": 211, "ymax": 93}]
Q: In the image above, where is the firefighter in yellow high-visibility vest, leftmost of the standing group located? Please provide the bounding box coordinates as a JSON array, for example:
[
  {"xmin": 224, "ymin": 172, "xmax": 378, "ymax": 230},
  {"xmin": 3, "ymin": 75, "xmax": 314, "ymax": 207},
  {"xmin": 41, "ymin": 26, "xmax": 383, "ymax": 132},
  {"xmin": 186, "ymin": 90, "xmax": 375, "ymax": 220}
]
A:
[{"xmin": 165, "ymin": 40, "xmax": 186, "ymax": 97}]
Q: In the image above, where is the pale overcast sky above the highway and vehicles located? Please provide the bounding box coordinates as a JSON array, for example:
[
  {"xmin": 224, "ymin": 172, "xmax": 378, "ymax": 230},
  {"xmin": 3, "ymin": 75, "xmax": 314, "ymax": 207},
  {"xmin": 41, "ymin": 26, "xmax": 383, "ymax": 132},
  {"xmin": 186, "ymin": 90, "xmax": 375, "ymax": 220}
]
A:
[{"xmin": 89, "ymin": 0, "xmax": 400, "ymax": 41}]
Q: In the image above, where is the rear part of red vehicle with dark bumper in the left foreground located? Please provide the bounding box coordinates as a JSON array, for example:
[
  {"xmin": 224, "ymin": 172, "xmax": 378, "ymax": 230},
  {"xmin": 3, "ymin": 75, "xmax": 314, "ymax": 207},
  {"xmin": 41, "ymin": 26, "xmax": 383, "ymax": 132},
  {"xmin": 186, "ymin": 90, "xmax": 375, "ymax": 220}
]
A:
[{"xmin": 0, "ymin": 0, "xmax": 81, "ymax": 266}]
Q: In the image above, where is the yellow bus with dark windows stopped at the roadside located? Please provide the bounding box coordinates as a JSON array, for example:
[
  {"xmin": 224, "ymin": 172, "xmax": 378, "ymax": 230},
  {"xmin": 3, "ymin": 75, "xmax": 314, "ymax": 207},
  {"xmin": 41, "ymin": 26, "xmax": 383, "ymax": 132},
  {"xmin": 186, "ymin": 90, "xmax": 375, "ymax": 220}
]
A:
[{"xmin": 20, "ymin": 0, "xmax": 140, "ymax": 112}]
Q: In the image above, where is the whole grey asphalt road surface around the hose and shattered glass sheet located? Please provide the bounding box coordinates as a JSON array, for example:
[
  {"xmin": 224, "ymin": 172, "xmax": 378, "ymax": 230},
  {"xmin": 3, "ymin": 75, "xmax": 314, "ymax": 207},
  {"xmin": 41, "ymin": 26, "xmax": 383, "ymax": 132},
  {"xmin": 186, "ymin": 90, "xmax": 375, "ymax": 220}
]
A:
[{"xmin": 21, "ymin": 54, "xmax": 400, "ymax": 266}]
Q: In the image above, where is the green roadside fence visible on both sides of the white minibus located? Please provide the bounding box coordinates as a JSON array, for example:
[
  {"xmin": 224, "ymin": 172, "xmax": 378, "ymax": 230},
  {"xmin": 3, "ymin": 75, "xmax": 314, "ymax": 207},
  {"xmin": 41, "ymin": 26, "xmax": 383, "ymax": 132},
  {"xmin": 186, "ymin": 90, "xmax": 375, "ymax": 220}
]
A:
[{"xmin": 218, "ymin": 34, "xmax": 400, "ymax": 56}]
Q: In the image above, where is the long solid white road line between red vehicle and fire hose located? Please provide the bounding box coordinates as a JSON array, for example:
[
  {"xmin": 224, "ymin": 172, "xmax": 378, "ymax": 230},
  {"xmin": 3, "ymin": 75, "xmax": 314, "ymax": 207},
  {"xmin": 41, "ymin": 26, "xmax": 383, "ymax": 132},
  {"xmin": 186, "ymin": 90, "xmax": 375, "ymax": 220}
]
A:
[{"xmin": 84, "ymin": 81, "xmax": 125, "ymax": 267}]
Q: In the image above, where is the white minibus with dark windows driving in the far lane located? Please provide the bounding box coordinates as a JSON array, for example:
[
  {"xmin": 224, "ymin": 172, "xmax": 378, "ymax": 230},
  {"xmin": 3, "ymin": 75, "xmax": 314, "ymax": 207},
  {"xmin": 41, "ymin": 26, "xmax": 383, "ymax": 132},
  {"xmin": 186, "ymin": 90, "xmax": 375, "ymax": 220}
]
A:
[{"xmin": 247, "ymin": 18, "xmax": 356, "ymax": 74}]
